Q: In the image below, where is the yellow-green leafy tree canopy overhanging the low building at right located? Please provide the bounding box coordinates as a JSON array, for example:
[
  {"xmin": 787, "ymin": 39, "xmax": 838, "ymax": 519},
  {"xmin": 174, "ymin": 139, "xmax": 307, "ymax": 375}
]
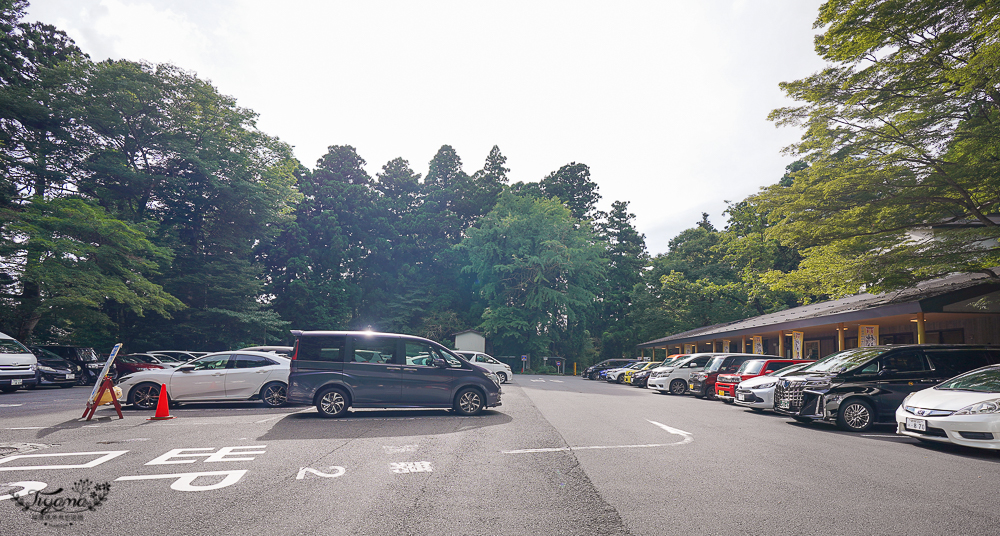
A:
[{"xmin": 761, "ymin": 0, "xmax": 1000, "ymax": 296}]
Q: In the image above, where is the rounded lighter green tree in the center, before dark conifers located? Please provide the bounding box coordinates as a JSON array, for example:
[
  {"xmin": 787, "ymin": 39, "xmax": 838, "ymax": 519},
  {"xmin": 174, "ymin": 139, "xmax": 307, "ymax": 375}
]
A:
[{"xmin": 461, "ymin": 192, "xmax": 604, "ymax": 362}]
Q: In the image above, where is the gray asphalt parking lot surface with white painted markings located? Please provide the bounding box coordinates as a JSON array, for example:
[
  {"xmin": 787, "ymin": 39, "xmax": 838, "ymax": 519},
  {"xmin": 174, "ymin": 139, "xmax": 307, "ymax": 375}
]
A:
[{"xmin": 0, "ymin": 376, "xmax": 1000, "ymax": 535}]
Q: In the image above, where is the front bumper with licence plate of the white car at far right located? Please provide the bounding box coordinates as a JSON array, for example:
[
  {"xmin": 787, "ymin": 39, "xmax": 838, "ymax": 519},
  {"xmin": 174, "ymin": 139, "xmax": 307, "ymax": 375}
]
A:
[{"xmin": 896, "ymin": 408, "xmax": 1000, "ymax": 450}]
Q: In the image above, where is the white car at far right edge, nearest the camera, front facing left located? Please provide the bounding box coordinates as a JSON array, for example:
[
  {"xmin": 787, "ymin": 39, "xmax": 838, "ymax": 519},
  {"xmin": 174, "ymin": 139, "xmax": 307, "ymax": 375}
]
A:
[{"xmin": 896, "ymin": 365, "xmax": 1000, "ymax": 449}]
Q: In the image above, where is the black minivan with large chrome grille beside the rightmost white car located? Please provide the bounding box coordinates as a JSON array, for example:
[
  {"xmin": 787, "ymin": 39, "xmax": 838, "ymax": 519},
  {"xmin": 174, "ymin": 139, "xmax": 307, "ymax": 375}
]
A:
[{"xmin": 774, "ymin": 344, "xmax": 1000, "ymax": 432}]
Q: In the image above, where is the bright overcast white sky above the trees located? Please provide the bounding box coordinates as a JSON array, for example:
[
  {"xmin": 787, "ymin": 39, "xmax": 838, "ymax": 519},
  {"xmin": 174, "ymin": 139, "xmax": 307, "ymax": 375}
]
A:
[{"xmin": 27, "ymin": 0, "xmax": 823, "ymax": 254}]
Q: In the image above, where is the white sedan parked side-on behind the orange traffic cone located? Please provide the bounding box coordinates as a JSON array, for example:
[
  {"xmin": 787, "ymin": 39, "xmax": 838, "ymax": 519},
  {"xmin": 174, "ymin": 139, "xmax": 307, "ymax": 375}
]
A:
[{"xmin": 117, "ymin": 350, "xmax": 291, "ymax": 409}]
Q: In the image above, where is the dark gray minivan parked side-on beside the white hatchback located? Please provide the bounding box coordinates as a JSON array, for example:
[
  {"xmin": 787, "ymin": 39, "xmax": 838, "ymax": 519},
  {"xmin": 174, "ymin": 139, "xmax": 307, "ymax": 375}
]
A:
[{"xmin": 288, "ymin": 330, "xmax": 500, "ymax": 417}]
